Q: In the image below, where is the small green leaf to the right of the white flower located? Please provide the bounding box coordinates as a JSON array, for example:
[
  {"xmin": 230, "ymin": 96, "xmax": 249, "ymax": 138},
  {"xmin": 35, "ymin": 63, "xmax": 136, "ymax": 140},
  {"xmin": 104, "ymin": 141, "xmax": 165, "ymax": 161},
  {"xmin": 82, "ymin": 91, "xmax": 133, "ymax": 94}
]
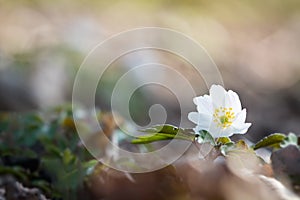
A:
[{"xmin": 253, "ymin": 133, "xmax": 286, "ymax": 150}]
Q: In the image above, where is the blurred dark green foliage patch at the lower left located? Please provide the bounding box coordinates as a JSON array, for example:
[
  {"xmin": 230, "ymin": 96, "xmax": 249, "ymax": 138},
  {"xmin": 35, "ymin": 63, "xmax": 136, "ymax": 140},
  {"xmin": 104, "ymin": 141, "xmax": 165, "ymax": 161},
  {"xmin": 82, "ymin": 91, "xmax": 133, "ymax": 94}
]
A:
[{"xmin": 0, "ymin": 105, "xmax": 98, "ymax": 199}]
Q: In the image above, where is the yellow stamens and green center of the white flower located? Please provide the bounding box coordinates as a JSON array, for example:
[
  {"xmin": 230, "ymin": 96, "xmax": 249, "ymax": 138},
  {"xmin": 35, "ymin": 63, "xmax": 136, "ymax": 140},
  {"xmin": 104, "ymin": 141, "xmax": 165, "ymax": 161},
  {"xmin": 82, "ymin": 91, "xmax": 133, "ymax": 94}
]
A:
[{"xmin": 213, "ymin": 107, "xmax": 235, "ymax": 129}]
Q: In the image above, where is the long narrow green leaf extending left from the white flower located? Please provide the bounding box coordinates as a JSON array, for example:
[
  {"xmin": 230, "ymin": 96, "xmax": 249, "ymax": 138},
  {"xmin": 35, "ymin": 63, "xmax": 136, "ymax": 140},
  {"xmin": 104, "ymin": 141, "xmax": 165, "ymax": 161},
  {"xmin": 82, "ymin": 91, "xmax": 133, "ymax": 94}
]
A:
[{"xmin": 131, "ymin": 124, "xmax": 196, "ymax": 144}]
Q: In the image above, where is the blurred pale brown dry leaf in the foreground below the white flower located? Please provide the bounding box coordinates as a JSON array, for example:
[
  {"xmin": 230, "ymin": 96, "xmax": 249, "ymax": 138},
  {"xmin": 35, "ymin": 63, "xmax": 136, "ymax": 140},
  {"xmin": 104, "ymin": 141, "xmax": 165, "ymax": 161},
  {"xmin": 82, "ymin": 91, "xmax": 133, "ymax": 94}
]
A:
[{"xmin": 176, "ymin": 145, "xmax": 298, "ymax": 200}]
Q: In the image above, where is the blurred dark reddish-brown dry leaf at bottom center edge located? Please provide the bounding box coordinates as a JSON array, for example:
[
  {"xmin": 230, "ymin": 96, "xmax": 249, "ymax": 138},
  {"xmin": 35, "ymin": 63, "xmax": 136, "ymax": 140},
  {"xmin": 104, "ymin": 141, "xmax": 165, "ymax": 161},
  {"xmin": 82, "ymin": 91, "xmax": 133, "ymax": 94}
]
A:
[{"xmin": 87, "ymin": 164, "xmax": 189, "ymax": 200}]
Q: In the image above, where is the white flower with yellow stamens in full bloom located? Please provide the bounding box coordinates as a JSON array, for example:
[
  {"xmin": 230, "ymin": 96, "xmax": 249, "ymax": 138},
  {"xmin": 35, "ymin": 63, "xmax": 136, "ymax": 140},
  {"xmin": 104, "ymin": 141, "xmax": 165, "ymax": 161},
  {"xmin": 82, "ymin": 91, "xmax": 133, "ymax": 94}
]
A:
[{"xmin": 188, "ymin": 85, "xmax": 251, "ymax": 138}]
